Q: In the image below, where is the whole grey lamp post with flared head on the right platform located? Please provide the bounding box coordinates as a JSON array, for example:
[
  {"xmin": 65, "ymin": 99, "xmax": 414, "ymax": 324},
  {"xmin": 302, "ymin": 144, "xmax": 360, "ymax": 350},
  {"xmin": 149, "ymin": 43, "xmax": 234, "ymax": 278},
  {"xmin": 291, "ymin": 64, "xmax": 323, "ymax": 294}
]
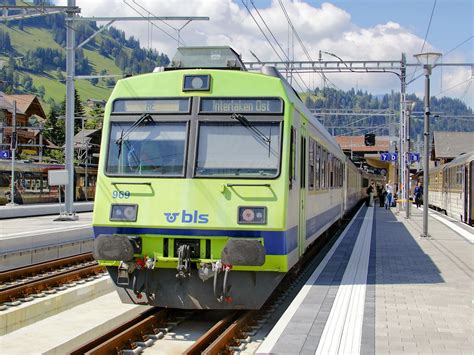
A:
[{"xmin": 414, "ymin": 52, "xmax": 441, "ymax": 237}]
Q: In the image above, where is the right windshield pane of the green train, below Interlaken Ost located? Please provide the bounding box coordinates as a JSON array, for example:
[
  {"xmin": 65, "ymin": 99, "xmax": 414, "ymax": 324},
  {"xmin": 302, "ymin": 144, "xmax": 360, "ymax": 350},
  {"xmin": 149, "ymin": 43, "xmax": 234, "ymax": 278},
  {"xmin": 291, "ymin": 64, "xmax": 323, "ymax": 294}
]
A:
[{"xmin": 195, "ymin": 121, "xmax": 281, "ymax": 177}]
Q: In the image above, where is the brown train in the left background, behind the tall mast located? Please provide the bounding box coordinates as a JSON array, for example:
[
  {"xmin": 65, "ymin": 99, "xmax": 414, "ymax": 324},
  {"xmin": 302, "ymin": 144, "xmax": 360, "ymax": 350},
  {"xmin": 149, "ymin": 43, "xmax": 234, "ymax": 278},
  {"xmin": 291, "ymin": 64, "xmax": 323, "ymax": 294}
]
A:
[{"xmin": 0, "ymin": 160, "xmax": 97, "ymax": 205}]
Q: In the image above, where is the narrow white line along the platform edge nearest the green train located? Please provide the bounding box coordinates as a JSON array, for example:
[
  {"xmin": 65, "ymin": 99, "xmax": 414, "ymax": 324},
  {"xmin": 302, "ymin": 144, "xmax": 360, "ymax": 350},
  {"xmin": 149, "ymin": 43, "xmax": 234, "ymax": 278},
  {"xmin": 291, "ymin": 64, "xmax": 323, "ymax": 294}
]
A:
[{"xmin": 257, "ymin": 206, "xmax": 364, "ymax": 354}]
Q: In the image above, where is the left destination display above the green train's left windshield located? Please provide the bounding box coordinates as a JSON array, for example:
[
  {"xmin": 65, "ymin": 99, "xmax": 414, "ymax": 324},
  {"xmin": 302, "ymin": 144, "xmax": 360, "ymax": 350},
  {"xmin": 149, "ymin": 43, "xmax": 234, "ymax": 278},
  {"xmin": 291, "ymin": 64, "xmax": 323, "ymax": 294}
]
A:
[{"xmin": 113, "ymin": 99, "xmax": 189, "ymax": 113}]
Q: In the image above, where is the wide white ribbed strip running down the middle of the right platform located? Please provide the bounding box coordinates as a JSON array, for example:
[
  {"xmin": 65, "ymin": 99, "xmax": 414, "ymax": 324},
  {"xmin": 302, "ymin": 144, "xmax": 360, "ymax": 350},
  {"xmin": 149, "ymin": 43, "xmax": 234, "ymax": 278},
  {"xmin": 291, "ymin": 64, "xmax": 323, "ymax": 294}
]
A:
[{"xmin": 316, "ymin": 208, "xmax": 374, "ymax": 355}]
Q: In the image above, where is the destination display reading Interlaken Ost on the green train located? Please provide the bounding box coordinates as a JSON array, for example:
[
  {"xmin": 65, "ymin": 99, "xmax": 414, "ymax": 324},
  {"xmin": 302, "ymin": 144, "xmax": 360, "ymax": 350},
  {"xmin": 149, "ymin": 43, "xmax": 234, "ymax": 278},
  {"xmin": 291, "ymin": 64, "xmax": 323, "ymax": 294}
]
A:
[{"xmin": 201, "ymin": 99, "xmax": 283, "ymax": 114}]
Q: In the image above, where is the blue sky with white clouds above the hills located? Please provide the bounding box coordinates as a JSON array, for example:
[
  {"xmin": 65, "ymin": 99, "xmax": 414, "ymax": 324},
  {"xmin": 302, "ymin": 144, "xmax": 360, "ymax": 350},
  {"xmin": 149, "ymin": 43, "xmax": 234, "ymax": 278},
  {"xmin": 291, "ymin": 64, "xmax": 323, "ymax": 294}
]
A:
[{"xmin": 57, "ymin": 0, "xmax": 474, "ymax": 108}]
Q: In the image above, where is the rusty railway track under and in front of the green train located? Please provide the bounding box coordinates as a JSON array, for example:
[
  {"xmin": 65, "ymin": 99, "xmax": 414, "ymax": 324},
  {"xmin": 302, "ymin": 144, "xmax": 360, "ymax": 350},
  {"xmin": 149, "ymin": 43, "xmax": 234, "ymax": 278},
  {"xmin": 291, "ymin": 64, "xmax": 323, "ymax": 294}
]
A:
[{"xmin": 71, "ymin": 207, "xmax": 360, "ymax": 355}]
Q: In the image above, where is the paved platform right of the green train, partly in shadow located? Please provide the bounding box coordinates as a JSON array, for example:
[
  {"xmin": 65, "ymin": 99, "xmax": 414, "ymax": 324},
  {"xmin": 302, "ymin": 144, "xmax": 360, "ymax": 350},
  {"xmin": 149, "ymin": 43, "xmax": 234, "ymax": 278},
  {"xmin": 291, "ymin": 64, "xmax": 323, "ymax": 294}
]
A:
[{"xmin": 257, "ymin": 206, "xmax": 474, "ymax": 354}]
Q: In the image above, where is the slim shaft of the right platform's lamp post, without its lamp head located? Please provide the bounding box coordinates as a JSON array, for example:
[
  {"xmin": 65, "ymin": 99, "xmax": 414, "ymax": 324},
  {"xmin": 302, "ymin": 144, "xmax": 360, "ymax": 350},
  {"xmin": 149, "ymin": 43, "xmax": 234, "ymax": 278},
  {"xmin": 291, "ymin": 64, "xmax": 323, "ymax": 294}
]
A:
[{"xmin": 421, "ymin": 64, "xmax": 431, "ymax": 237}]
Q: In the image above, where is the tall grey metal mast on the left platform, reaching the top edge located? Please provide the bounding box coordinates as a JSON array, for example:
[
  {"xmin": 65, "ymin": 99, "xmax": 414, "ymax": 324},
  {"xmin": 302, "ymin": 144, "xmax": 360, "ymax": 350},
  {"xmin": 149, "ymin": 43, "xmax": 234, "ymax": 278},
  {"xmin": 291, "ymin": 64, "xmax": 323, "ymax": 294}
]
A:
[{"xmin": 64, "ymin": 0, "xmax": 77, "ymax": 220}]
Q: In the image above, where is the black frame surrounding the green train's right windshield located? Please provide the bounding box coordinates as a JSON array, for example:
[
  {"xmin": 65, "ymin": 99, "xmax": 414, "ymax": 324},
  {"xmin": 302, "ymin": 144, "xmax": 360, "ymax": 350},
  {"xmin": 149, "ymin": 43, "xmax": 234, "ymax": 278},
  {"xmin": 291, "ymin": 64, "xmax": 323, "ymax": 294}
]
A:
[{"xmin": 192, "ymin": 119, "xmax": 284, "ymax": 180}]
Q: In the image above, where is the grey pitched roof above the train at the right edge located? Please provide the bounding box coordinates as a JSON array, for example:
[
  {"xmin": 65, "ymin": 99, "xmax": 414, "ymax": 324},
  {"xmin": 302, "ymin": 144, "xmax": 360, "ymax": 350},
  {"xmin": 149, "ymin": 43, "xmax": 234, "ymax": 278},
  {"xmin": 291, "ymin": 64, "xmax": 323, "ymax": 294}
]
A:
[{"xmin": 433, "ymin": 131, "xmax": 474, "ymax": 158}]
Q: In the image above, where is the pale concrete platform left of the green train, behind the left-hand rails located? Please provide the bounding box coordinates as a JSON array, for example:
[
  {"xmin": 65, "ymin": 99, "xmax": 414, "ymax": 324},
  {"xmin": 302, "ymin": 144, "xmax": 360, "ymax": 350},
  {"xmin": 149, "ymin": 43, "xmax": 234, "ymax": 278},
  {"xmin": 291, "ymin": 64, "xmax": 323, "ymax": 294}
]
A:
[{"xmin": 0, "ymin": 212, "xmax": 93, "ymax": 271}]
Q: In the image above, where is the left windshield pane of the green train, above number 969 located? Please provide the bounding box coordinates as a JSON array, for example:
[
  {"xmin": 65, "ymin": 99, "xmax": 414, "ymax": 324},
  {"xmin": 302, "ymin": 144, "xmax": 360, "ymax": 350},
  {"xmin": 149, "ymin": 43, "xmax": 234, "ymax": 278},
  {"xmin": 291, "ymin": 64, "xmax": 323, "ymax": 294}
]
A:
[{"xmin": 107, "ymin": 121, "xmax": 186, "ymax": 176}]
